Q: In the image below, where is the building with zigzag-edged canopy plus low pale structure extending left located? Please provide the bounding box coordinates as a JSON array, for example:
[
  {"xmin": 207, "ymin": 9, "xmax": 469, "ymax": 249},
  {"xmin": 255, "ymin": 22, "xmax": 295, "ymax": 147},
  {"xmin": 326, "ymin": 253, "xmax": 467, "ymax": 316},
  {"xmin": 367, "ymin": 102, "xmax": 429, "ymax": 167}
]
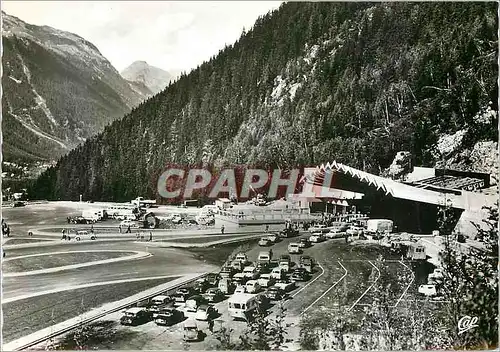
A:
[{"xmin": 215, "ymin": 161, "xmax": 498, "ymax": 234}]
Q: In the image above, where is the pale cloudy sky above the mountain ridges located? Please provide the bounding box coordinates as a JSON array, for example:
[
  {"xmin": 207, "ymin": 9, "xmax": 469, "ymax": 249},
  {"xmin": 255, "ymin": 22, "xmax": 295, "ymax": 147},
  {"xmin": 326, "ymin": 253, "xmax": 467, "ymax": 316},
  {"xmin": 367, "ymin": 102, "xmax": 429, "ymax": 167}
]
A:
[{"xmin": 2, "ymin": 0, "xmax": 281, "ymax": 72}]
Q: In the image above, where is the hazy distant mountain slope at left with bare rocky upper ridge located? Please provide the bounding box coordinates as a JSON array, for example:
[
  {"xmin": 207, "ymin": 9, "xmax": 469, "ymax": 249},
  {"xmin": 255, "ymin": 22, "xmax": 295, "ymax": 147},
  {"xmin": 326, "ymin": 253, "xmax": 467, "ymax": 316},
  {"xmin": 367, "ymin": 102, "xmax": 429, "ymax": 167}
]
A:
[{"xmin": 2, "ymin": 12, "xmax": 147, "ymax": 162}]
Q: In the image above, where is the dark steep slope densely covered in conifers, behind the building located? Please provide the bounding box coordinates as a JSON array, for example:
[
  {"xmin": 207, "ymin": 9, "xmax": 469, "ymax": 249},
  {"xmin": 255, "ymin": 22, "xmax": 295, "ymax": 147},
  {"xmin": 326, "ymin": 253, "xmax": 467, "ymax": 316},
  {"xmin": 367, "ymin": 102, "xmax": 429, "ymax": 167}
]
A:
[{"xmin": 32, "ymin": 2, "xmax": 498, "ymax": 200}]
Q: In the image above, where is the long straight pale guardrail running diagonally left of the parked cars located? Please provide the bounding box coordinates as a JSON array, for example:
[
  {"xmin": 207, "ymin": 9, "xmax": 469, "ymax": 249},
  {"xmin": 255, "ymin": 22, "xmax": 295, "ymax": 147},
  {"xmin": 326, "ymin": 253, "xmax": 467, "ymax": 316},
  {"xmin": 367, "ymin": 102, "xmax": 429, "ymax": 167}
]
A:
[{"xmin": 2, "ymin": 273, "xmax": 208, "ymax": 351}]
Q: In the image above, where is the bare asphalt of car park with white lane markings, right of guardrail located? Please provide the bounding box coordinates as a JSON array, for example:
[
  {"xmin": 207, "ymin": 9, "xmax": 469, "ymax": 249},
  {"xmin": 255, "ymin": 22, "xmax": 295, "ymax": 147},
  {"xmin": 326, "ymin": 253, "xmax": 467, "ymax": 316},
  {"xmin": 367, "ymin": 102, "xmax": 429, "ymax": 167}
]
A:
[{"xmin": 27, "ymin": 228, "xmax": 436, "ymax": 350}]
